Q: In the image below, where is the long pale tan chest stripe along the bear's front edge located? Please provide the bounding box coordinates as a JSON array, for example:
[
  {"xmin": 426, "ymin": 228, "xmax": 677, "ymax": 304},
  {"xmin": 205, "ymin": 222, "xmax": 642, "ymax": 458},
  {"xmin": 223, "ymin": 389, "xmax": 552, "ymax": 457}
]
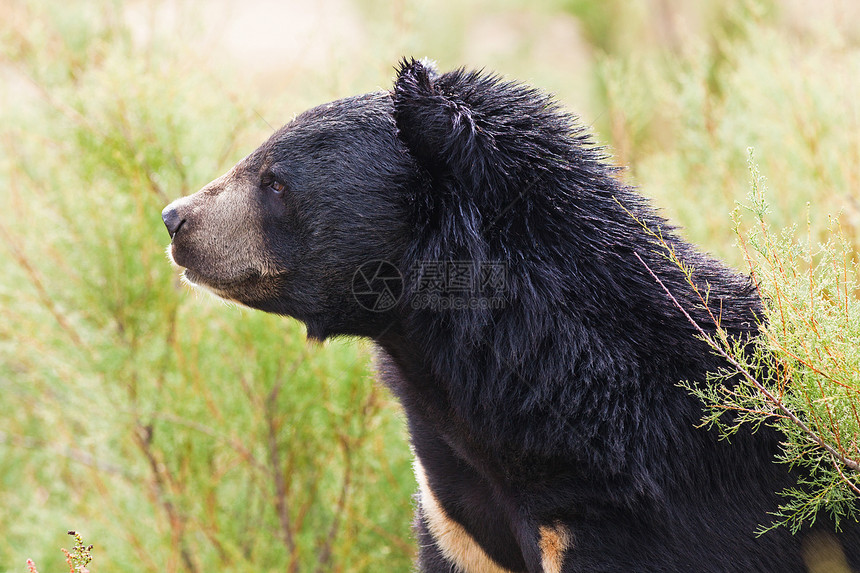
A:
[{"xmin": 414, "ymin": 457, "xmax": 511, "ymax": 573}]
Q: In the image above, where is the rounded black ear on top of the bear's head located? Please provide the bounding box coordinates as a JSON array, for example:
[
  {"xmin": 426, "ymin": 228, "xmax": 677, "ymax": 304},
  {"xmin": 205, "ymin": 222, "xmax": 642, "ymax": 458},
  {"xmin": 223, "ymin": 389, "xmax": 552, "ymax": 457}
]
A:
[{"xmin": 394, "ymin": 59, "xmax": 486, "ymax": 184}]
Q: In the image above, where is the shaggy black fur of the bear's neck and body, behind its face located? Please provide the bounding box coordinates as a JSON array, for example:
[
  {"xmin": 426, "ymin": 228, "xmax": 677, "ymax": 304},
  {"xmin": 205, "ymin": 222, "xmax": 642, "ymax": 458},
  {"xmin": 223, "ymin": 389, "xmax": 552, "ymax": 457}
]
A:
[{"xmin": 379, "ymin": 62, "xmax": 860, "ymax": 571}]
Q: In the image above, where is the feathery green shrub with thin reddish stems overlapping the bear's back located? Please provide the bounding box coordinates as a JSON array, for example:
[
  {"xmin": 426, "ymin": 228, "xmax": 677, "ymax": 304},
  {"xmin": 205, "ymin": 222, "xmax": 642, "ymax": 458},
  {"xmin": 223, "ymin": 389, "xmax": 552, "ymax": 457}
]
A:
[{"xmin": 683, "ymin": 155, "xmax": 860, "ymax": 531}]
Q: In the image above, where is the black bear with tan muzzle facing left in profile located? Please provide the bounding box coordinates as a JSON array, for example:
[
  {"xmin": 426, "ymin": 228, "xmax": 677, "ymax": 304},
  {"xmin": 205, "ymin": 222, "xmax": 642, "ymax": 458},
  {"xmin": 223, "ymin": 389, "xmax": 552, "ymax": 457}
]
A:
[{"xmin": 162, "ymin": 60, "xmax": 860, "ymax": 573}]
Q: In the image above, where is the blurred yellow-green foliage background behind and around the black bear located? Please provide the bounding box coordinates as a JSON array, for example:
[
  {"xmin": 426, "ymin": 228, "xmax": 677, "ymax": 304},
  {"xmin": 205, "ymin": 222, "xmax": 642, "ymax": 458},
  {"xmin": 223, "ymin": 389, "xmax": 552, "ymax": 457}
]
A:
[{"xmin": 0, "ymin": 0, "xmax": 860, "ymax": 572}]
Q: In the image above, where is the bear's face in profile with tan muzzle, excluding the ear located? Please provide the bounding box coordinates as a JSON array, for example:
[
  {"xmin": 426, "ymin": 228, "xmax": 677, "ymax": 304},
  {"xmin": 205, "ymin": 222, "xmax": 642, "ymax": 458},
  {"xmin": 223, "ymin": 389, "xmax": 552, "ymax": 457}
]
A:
[{"xmin": 162, "ymin": 92, "xmax": 424, "ymax": 338}]
